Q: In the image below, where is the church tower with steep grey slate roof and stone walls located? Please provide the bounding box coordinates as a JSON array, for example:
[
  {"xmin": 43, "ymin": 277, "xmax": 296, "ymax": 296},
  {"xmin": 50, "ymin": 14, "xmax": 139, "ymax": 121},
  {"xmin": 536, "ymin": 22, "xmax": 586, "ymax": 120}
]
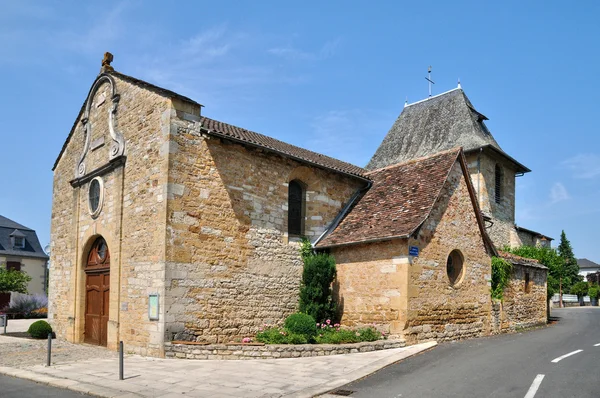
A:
[{"xmin": 366, "ymin": 85, "xmax": 552, "ymax": 248}]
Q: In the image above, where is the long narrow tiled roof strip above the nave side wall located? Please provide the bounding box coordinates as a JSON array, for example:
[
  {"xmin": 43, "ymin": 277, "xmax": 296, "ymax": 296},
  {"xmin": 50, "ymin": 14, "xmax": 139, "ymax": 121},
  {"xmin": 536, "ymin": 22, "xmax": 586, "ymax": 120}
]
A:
[{"xmin": 201, "ymin": 117, "xmax": 367, "ymax": 179}]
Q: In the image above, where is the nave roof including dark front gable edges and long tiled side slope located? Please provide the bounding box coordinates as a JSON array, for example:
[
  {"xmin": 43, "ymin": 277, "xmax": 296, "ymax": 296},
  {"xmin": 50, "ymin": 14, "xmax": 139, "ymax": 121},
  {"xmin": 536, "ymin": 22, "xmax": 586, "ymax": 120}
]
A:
[{"xmin": 52, "ymin": 70, "xmax": 366, "ymax": 179}]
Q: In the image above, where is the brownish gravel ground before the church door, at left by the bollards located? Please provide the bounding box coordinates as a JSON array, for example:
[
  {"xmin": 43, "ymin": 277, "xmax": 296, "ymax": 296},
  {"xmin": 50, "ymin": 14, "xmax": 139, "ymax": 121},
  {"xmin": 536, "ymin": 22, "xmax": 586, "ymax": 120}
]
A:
[{"xmin": 0, "ymin": 335, "xmax": 118, "ymax": 368}]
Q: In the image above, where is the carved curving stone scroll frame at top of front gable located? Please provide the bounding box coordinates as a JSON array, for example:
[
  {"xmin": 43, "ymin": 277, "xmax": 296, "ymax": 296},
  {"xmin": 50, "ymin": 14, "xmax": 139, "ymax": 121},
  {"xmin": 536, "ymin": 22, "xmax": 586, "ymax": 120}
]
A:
[{"xmin": 75, "ymin": 73, "xmax": 125, "ymax": 178}]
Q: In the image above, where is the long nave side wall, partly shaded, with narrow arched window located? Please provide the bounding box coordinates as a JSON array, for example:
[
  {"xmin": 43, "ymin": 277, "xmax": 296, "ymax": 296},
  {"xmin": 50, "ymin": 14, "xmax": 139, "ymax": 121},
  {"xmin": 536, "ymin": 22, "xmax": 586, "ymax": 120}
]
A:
[{"xmin": 165, "ymin": 120, "xmax": 365, "ymax": 343}]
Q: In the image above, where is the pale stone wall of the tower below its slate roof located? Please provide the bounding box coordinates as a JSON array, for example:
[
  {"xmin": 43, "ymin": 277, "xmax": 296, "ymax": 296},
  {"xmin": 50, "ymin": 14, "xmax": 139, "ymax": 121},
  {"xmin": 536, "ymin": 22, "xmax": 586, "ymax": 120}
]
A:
[{"xmin": 467, "ymin": 152, "xmax": 515, "ymax": 248}]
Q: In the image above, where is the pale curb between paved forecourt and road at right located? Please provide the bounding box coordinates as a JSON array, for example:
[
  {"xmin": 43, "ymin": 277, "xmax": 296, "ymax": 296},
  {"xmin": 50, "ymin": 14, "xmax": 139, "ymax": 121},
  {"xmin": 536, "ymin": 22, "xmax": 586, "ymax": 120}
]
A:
[{"xmin": 284, "ymin": 341, "xmax": 437, "ymax": 398}]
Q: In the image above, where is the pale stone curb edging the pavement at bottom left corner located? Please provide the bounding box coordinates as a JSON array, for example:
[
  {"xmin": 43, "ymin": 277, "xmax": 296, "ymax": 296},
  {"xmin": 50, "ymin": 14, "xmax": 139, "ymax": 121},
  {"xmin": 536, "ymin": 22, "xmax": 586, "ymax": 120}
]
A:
[{"xmin": 0, "ymin": 366, "xmax": 136, "ymax": 398}]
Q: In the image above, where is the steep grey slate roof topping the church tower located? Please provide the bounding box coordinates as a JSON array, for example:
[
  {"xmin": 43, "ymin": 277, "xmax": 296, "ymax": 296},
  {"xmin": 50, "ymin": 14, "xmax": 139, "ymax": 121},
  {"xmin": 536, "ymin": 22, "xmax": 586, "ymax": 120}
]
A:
[{"xmin": 366, "ymin": 88, "xmax": 531, "ymax": 172}]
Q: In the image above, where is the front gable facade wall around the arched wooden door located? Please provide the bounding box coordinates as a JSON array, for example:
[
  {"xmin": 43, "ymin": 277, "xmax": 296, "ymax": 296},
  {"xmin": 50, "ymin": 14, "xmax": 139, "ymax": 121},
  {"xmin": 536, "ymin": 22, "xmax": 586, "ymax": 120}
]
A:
[{"xmin": 49, "ymin": 73, "xmax": 171, "ymax": 356}]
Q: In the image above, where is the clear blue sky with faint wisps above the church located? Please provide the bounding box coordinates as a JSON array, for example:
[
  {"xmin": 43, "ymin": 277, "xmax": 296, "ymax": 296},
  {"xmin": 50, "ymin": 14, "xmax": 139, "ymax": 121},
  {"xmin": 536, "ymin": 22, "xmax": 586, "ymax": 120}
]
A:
[{"xmin": 0, "ymin": 0, "xmax": 600, "ymax": 262}]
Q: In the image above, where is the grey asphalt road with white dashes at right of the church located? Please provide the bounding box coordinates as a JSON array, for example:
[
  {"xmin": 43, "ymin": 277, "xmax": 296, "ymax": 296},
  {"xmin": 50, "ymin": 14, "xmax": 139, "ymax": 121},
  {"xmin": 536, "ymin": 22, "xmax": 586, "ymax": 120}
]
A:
[{"xmin": 330, "ymin": 307, "xmax": 600, "ymax": 398}]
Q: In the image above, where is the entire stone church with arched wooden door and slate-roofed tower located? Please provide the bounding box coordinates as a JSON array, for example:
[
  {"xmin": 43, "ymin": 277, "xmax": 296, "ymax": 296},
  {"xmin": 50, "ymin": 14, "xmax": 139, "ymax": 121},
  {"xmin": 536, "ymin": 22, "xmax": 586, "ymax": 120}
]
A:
[{"xmin": 49, "ymin": 53, "xmax": 549, "ymax": 356}]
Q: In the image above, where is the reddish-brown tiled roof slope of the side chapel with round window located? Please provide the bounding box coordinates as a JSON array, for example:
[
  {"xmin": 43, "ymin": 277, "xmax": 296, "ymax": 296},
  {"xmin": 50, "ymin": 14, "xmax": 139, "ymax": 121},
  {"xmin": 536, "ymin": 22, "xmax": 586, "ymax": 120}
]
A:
[{"xmin": 317, "ymin": 148, "xmax": 461, "ymax": 247}]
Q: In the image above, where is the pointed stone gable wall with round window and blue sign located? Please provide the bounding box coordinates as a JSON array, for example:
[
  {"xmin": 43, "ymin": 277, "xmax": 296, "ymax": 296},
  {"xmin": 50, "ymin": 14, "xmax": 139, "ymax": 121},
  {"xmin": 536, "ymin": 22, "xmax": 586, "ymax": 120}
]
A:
[{"xmin": 404, "ymin": 162, "xmax": 491, "ymax": 344}]
